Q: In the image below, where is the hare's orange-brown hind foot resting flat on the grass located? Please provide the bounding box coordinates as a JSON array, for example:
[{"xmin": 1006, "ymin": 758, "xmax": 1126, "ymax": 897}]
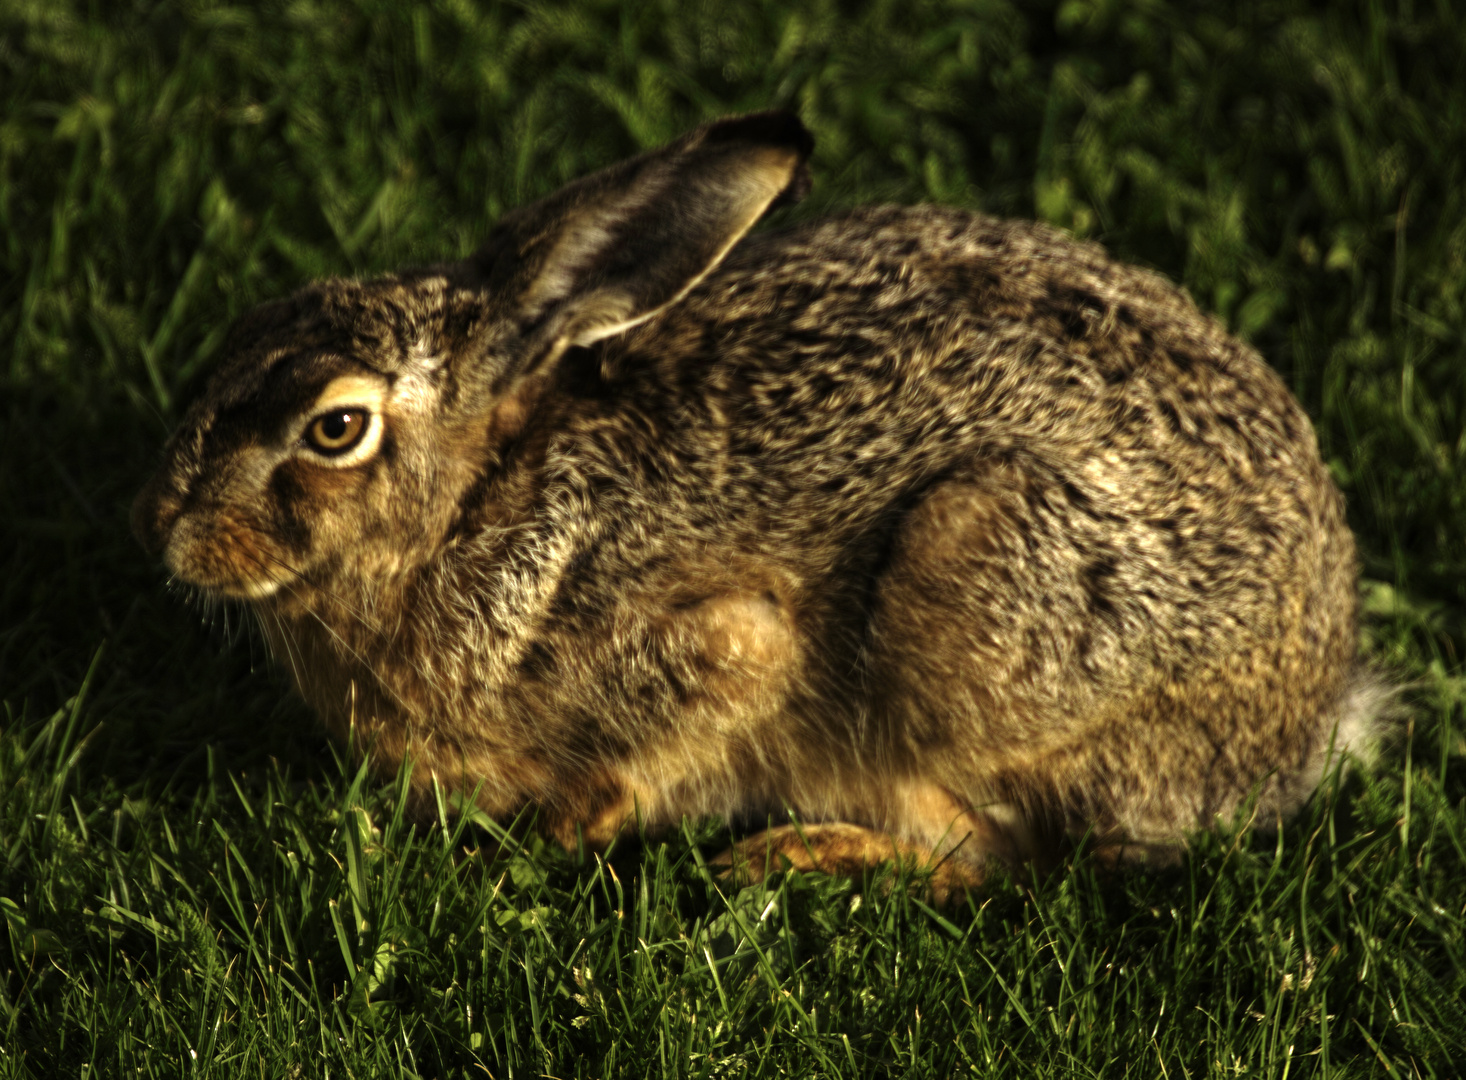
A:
[{"xmin": 711, "ymin": 822, "xmax": 982, "ymax": 903}]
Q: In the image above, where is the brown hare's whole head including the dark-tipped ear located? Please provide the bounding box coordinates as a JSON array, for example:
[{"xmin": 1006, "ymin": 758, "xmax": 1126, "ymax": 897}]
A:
[{"xmin": 132, "ymin": 113, "xmax": 811, "ymax": 599}]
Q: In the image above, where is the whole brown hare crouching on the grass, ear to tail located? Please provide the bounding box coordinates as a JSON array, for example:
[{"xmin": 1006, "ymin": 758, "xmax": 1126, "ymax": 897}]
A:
[{"xmin": 133, "ymin": 113, "xmax": 1387, "ymax": 892}]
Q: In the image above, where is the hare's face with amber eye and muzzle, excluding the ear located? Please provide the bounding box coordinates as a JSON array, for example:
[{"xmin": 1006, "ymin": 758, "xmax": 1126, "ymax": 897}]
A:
[{"xmin": 133, "ymin": 271, "xmax": 494, "ymax": 599}]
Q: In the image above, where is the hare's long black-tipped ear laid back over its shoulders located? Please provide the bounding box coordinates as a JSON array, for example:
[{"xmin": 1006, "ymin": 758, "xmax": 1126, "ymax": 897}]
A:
[{"xmin": 476, "ymin": 113, "xmax": 814, "ymax": 375}]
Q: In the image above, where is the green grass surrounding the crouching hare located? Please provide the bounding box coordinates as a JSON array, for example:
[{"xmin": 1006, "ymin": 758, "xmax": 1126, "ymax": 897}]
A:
[{"xmin": 0, "ymin": 0, "xmax": 1466, "ymax": 1080}]
